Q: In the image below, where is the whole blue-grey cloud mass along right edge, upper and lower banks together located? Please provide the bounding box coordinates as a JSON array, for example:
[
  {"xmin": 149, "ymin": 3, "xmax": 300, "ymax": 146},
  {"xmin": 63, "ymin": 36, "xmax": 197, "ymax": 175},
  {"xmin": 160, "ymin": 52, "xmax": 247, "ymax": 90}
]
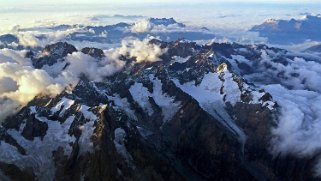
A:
[{"xmin": 241, "ymin": 51, "xmax": 321, "ymax": 176}]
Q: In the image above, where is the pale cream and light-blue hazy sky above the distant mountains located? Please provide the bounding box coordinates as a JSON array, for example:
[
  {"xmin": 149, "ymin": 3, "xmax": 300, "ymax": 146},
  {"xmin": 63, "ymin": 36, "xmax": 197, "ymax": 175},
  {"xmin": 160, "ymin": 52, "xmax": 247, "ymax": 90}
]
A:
[{"xmin": 0, "ymin": 0, "xmax": 321, "ymax": 34}]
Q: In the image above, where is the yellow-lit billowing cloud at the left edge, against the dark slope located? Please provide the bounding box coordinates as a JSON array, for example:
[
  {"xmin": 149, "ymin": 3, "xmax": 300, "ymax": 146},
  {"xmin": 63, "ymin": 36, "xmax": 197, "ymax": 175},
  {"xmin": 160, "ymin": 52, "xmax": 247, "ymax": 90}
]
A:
[{"xmin": 0, "ymin": 50, "xmax": 63, "ymax": 120}]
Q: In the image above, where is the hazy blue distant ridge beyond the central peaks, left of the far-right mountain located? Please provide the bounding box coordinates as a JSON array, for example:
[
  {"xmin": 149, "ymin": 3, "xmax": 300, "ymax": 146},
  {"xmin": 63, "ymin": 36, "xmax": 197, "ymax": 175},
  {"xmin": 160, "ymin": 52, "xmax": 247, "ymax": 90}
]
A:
[{"xmin": 67, "ymin": 18, "xmax": 212, "ymax": 43}]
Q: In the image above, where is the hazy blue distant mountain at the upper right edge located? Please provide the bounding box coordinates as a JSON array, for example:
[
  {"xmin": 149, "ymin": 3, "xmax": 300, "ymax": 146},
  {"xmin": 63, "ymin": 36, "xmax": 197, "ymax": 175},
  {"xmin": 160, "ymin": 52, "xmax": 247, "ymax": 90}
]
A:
[{"xmin": 250, "ymin": 15, "xmax": 321, "ymax": 44}]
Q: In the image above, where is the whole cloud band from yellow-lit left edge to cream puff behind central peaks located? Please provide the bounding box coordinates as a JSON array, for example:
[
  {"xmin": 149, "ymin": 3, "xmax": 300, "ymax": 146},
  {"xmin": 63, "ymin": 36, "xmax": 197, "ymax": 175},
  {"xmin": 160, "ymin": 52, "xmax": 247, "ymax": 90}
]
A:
[{"xmin": 0, "ymin": 38, "xmax": 165, "ymax": 121}]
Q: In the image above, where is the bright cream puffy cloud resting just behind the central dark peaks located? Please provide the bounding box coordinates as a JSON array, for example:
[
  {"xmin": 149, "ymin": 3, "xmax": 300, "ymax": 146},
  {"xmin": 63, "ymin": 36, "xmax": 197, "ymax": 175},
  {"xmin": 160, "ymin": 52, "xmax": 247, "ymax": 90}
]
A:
[{"xmin": 113, "ymin": 37, "xmax": 167, "ymax": 63}]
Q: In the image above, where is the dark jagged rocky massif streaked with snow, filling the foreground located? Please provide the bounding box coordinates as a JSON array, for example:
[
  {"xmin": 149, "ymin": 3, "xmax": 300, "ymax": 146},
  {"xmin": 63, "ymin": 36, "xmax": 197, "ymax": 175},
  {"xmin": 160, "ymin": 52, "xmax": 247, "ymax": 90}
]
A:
[{"xmin": 0, "ymin": 40, "xmax": 313, "ymax": 180}]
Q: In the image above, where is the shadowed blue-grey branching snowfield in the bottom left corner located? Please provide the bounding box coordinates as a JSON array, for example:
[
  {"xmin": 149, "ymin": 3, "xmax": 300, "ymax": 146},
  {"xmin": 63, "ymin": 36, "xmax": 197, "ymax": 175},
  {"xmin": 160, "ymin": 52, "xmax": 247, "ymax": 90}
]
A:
[{"xmin": 0, "ymin": 116, "xmax": 76, "ymax": 180}]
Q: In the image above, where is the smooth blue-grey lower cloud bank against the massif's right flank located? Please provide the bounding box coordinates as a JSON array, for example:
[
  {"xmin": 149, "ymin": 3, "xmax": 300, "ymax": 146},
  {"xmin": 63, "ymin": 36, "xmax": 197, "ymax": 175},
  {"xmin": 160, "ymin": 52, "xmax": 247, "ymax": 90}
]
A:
[{"xmin": 264, "ymin": 84, "xmax": 321, "ymax": 177}]
